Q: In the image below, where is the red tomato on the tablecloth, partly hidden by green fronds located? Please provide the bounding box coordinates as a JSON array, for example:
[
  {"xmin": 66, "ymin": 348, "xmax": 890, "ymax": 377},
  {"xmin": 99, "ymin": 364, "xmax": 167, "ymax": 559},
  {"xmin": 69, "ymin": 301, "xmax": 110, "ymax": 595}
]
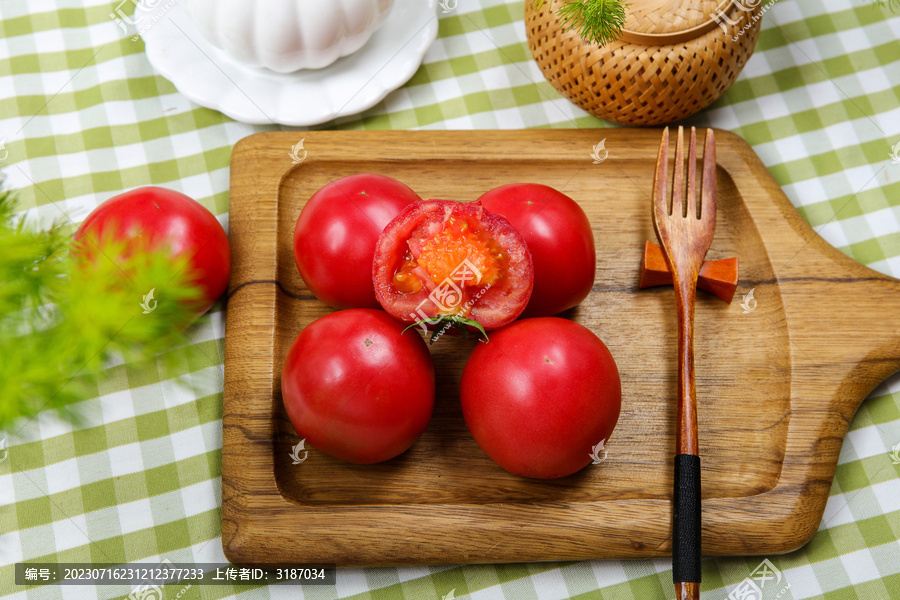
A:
[{"xmin": 73, "ymin": 186, "xmax": 231, "ymax": 314}]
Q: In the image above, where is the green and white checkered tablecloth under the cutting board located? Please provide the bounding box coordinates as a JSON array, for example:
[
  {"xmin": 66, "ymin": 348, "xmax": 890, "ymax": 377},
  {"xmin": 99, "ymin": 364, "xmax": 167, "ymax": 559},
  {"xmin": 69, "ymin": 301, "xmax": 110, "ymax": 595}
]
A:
[{"xmin": 0, "ymin": 0, "xmax": 900, "ymax": 600}]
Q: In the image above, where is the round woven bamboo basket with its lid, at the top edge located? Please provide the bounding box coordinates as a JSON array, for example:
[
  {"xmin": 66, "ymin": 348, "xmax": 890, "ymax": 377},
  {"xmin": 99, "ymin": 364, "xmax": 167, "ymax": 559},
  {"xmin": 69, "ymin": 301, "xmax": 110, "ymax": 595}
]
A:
[{"xmin": 525, "ymin": 0, "xmax": 763, "ymax": 125}]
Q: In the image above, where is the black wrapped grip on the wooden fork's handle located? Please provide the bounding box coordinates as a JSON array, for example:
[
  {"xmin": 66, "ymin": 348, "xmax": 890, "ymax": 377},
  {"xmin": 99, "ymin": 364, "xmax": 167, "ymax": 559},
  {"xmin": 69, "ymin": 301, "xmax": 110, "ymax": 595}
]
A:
[{"xmin": 672, "ymin": 454, "xmax": 700, "ymax": 583}]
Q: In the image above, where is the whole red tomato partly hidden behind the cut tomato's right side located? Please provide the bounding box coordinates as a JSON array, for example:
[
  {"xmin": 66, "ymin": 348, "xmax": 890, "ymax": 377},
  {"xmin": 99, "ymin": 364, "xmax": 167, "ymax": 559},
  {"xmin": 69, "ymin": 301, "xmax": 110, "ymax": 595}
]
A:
[{"xmin": 478, "ymin": 183, "xmax": 597, "ymax": 317}]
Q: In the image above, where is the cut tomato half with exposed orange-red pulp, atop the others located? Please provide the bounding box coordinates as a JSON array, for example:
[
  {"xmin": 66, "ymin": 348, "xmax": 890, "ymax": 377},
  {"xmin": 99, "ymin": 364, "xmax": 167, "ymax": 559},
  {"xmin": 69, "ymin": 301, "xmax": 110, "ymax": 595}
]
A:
[{"xmin": 373, "ymin": 200, "xmax": 533, "ymax": 330}]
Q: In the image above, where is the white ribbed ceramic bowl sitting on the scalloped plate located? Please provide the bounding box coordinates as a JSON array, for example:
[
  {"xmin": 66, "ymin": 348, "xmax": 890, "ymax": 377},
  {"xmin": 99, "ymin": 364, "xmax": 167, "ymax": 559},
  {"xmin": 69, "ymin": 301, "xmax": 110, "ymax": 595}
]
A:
[{"xmin": 188, "ymin": 0, "xmax": 394, "ymax": 73}]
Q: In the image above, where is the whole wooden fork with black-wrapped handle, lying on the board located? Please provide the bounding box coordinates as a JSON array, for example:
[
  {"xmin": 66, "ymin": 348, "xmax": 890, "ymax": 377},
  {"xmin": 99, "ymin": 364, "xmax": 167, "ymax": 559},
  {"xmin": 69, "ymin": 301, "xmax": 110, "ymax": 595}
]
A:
[{"xmin": 653, "ymin": 127, "xmax": 716, "ymax": 600}]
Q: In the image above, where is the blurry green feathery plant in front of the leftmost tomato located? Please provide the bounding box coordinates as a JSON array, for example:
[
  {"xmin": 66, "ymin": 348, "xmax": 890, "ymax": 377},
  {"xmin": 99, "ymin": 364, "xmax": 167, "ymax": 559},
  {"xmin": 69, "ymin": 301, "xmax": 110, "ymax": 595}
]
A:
[{"xmin": 0, "ymin": 178, "xmax": 202, "ymax": 432}]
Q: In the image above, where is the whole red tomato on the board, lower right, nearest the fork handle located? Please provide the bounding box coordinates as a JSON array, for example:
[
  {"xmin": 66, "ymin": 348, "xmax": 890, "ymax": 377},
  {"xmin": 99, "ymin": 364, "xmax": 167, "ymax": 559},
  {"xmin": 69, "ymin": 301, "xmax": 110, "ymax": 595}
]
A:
[{"xmin": 460, "ymin": 317, "xmax": 622, "ymax": 479}]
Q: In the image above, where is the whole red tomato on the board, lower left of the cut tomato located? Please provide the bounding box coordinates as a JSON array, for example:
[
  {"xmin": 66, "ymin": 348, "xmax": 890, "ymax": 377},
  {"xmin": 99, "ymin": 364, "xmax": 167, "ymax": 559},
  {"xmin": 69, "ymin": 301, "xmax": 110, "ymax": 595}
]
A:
[{"xmin": 281, "ymin": 308, "xmax": 434, "ymax": 464}]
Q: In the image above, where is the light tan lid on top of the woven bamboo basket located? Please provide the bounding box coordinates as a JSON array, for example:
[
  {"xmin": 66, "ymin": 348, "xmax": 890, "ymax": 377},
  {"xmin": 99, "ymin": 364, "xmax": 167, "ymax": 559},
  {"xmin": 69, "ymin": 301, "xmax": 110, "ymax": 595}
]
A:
[{"xmin": 620, "ymin": 0, "xmax": 740, "ymax": 45}]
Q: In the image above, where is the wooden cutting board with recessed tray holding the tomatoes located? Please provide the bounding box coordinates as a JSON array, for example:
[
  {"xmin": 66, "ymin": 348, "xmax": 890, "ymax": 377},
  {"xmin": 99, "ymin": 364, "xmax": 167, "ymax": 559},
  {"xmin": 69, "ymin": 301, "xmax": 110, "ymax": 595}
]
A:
[{"xmin": 222, "ymin": 129, "xmax": 900, "ymax": 565}]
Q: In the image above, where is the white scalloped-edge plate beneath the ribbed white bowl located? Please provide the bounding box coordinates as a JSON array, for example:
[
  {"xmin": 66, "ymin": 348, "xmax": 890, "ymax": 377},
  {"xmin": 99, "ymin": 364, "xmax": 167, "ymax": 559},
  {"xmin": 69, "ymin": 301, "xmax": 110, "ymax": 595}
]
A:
[{"xmin": 135, "ymin": 0, "xmax": 438, "ymax": 126}]
